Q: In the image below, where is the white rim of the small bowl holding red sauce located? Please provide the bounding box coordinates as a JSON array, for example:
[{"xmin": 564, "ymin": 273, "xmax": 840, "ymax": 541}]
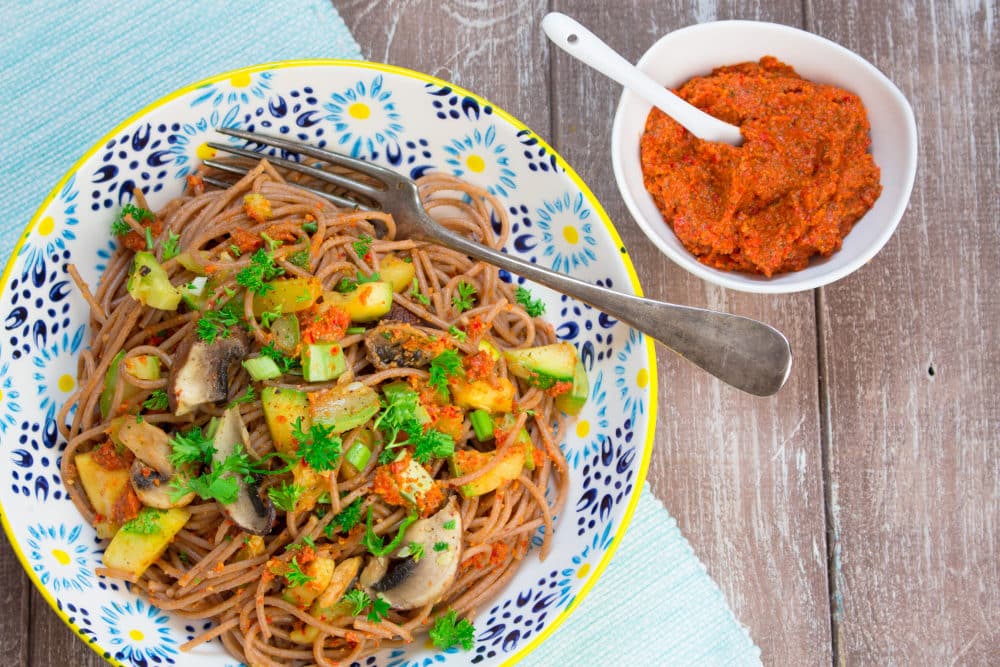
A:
[{"xmin": 611, "ymin": 20, "xmax": 918, "ymax": 294}]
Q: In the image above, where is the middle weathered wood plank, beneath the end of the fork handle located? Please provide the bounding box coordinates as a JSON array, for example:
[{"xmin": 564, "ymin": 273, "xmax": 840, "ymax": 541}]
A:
[{"xmin": 553, "ymin": 0, "xmax": 830, "ymax": 665}]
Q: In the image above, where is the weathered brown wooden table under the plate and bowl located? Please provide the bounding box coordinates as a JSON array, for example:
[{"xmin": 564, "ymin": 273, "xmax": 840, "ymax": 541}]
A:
[{"xmin": 0, "ymin": 0, "xmax": 1000, "ymax": 666}]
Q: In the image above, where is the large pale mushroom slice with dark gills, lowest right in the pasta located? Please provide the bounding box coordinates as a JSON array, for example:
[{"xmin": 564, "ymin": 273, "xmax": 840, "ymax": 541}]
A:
[{"xmin": 360, "ymin": 497, "xmax": 462, "ymax": 609}]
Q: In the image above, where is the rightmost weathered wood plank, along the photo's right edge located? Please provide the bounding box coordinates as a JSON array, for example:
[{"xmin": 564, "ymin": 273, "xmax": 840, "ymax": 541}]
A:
[{"xmin": 809, "ymin": 1, "xmax": 1000, "ymax": 665}]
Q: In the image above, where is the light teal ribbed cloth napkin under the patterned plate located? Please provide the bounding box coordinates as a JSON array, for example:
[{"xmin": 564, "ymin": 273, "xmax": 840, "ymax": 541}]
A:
[{"xmin": 0, "ymin": 0, "xmax": 760, "ymax": 665}]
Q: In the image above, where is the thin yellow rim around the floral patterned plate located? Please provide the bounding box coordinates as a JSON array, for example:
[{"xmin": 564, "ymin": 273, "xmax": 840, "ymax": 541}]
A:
[{"xmin": 0, "ymin": 58, "xmax": 659, "ymax": 667}]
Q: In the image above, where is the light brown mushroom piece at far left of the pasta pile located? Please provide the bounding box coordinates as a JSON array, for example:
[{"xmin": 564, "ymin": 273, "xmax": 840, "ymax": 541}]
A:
[{"xmin": 118, "ymin": 419, "xmax": 195, "ymax": 509}]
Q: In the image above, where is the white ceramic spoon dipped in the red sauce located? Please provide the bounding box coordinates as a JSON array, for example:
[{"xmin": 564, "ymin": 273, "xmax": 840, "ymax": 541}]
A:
[{"xmin": 542, "ymin": 12, "xmax": 743, "ymax": 146}]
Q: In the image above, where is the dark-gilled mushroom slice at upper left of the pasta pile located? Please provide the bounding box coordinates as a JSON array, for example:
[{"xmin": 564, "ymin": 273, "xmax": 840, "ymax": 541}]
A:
[{"xmin": 167, "ymin": 332, "xmax": 247, "ymax": 416}]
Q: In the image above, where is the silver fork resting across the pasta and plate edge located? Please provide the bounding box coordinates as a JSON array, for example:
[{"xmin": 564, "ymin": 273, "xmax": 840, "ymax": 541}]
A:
[{"xmin": 205, "ymin": 128, "xmax": 792, "ymax": 396}]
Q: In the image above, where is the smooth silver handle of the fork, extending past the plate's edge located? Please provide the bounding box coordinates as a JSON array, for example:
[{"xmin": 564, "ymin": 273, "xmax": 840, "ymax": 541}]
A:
[{"xmin": 436, "ymin": 229, "xmax": 792, "ymax": 396}]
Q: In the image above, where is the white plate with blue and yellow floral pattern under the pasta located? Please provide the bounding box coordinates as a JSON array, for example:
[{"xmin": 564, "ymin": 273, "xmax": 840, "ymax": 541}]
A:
[{"xmin": 0, "ymin": 61, "xmax": 656, "ymax": 667}]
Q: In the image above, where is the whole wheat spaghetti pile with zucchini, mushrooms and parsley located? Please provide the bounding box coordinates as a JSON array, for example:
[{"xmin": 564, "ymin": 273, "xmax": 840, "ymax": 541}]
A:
[{"xmin": 58, "ymin": 161, "xmax": 570, "ymax": 665}]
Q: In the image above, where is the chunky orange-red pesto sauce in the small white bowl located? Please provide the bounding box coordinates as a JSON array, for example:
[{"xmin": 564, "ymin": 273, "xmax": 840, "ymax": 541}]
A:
[{"xmin": 640, "ymin": 56, "xmax": 882, "ymax": 277}]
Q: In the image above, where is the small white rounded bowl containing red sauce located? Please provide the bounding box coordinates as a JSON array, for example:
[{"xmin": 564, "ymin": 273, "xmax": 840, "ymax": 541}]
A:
[{"xmin": 611, "ymin": 21, "xmax": 917, "ymax": 294}]
